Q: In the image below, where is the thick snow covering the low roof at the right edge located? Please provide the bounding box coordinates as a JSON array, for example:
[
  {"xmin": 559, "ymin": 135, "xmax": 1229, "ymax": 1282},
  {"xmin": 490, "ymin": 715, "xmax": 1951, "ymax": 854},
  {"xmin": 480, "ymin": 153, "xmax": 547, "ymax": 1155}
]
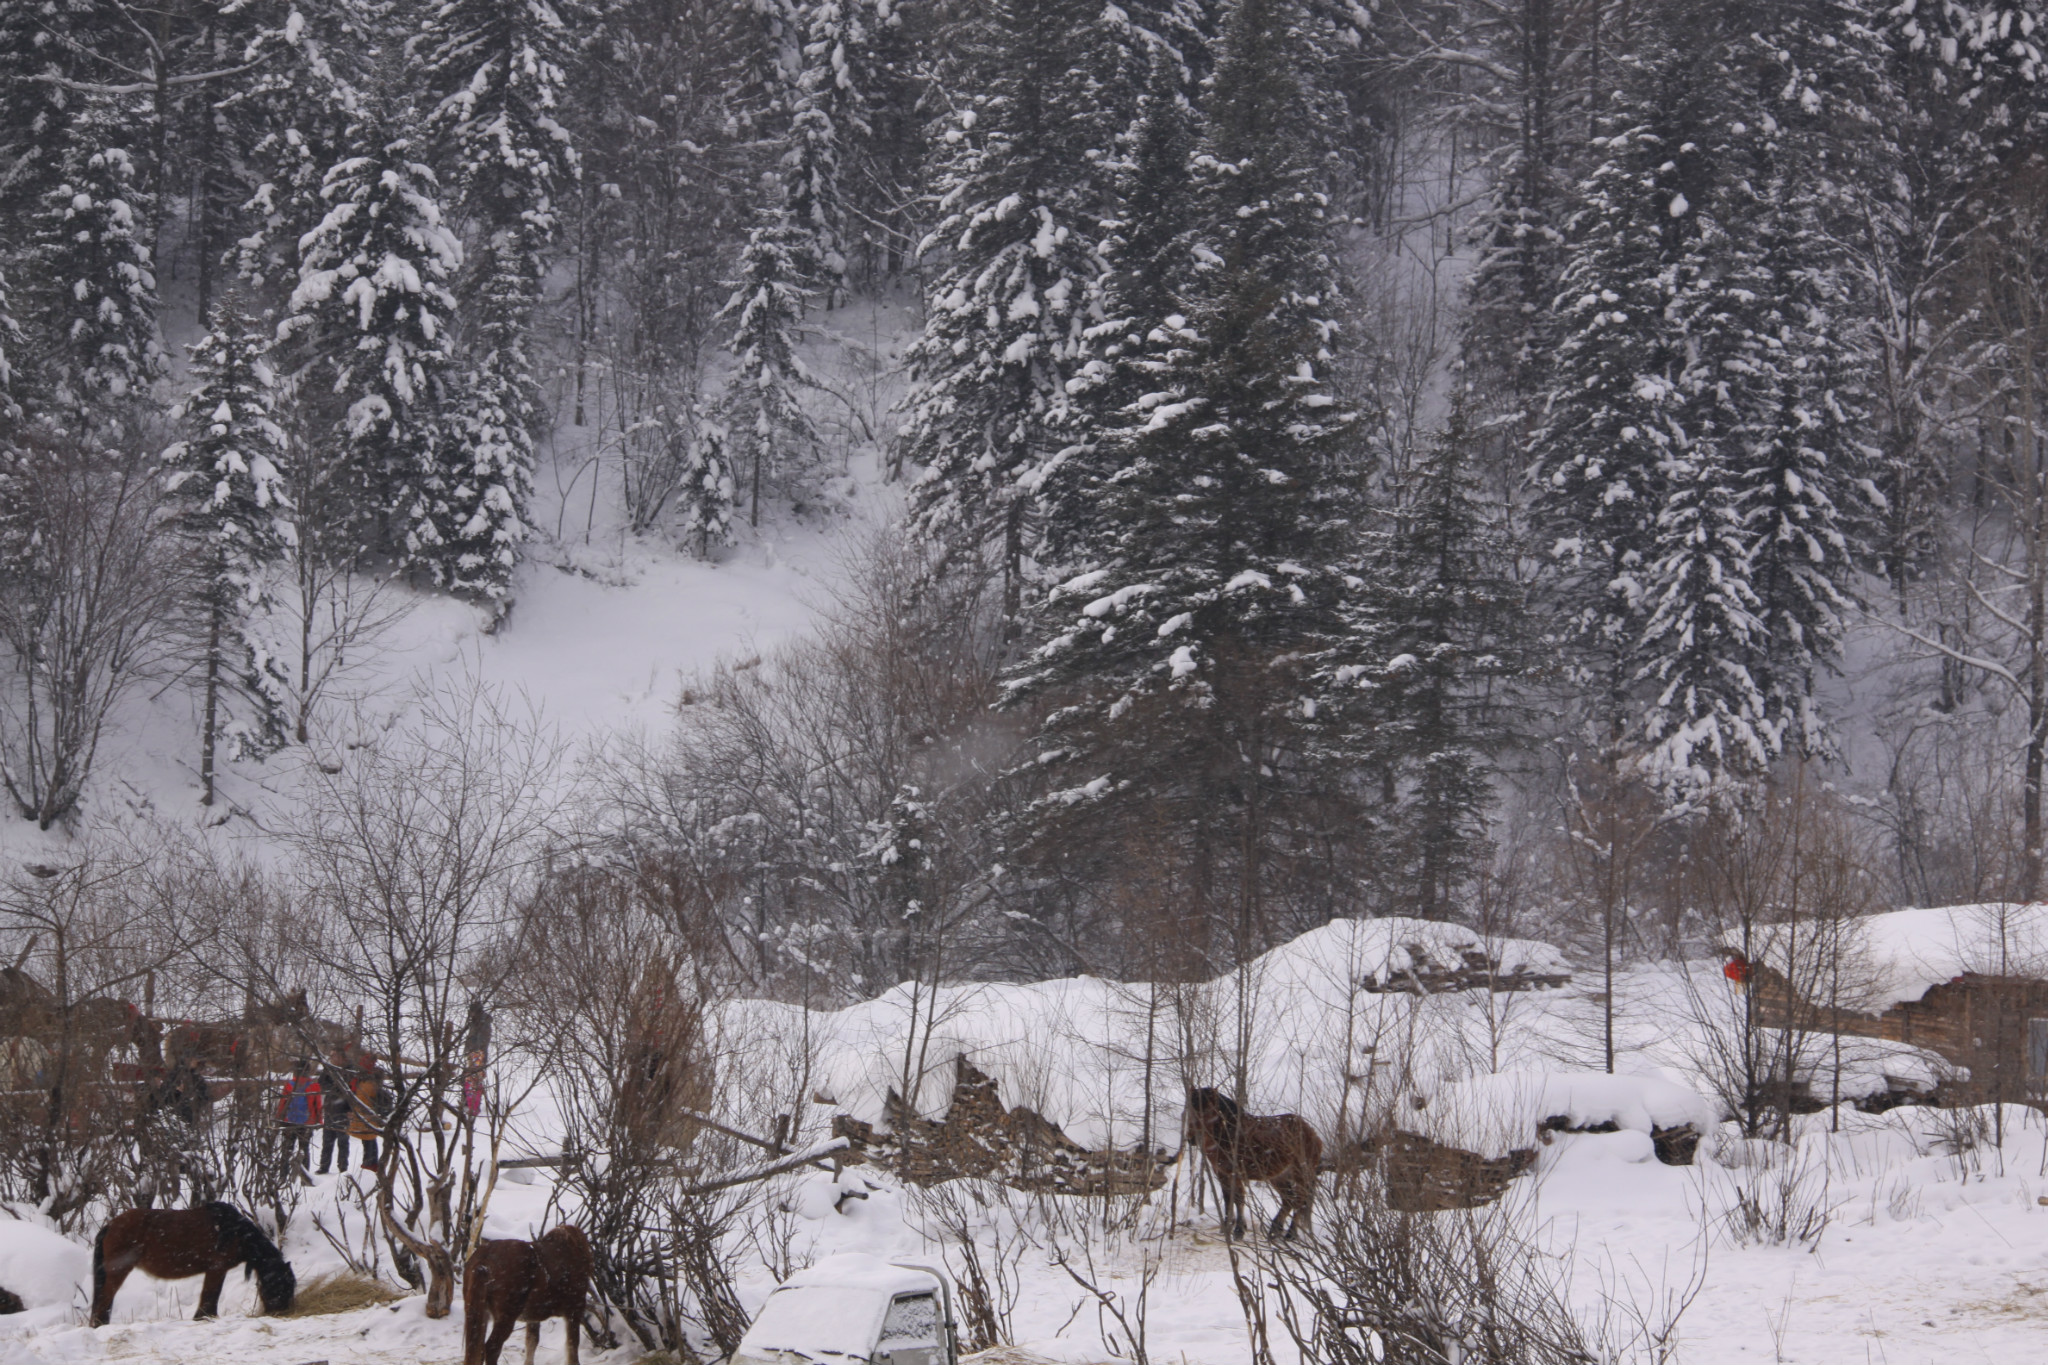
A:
[{"xmin": 1724, "ymin": 900, "xmax": 2048, "ymax": 1013}]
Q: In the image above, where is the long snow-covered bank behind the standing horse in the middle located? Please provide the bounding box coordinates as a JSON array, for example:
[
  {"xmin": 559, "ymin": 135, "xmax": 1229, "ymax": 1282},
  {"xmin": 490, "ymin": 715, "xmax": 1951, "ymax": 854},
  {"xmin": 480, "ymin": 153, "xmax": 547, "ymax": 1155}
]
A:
[{"xmin": 719, "ymin": 919, "xmax": 1571, "ymax": 1150}]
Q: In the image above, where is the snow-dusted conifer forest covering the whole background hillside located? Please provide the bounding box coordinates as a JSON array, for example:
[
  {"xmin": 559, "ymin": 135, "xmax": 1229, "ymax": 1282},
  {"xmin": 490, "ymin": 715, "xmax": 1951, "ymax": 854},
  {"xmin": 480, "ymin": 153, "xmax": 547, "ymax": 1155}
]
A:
[{"xmin": 0, "ymin": 0, "xmax": 2048, "ymax": 999}]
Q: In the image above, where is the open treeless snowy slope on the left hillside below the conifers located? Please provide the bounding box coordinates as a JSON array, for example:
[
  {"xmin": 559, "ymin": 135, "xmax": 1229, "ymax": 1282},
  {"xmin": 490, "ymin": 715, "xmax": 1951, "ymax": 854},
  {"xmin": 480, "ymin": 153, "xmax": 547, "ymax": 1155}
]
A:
[{"xmin": 0, "ymin": 454, "xmax": 899, "ymax": 862}]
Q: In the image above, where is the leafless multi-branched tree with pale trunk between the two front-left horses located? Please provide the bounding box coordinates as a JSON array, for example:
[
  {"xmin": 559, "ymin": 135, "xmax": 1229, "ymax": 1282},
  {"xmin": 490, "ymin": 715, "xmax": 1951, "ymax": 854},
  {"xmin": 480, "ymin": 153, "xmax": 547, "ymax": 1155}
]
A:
[{"xmin": 293, "ymin": 684, "xmax": 565, "ymax": 1318}]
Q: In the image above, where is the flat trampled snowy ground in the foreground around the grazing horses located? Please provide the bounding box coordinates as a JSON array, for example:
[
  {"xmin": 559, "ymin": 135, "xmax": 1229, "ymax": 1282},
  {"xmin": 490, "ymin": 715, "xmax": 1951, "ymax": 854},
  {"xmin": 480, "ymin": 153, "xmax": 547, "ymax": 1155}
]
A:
[{"xmin": 0, "ymin": 1119, "xmax": 2048, "ymax": 1365}]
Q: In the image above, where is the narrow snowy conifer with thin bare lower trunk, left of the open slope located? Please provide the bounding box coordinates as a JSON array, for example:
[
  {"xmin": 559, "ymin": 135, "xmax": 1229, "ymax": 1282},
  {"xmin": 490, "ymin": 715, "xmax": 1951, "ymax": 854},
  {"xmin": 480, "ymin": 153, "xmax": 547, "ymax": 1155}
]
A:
[{"xmin": 164, "ymin": 299, "xmax": 293, "ymax": 806}]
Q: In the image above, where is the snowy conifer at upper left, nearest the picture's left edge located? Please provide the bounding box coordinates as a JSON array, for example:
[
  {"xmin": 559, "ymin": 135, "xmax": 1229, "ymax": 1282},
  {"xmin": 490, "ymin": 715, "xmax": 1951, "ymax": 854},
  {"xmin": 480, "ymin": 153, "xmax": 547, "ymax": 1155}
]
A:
[{"xmin": 18, "ymin": 96, "xmax": 164, "ymax": 426}]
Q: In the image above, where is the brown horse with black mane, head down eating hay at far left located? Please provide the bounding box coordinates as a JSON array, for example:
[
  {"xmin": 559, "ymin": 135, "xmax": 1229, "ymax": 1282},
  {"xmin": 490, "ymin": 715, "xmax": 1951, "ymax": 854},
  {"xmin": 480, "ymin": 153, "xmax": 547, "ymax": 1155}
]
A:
[{"xmin": 88, "ymin": 1203, "xmax": 299, "ymax": 1326}]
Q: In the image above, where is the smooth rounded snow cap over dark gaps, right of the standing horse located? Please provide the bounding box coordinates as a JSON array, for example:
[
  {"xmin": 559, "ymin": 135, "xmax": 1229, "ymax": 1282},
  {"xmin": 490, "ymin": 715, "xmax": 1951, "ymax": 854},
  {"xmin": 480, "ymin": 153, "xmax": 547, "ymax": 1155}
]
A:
[{"xmin": 1401, "ymin": 1070, "xmax": 1720, "ymax": 1156}]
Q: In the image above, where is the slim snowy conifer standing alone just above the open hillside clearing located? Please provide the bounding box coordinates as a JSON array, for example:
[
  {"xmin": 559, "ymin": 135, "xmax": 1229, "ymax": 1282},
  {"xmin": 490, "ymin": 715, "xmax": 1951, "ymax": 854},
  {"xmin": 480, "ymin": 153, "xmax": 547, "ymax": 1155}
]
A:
[{"xmin": 719, "ymin": 211, "xmax": 819, "ymax": 526}]
